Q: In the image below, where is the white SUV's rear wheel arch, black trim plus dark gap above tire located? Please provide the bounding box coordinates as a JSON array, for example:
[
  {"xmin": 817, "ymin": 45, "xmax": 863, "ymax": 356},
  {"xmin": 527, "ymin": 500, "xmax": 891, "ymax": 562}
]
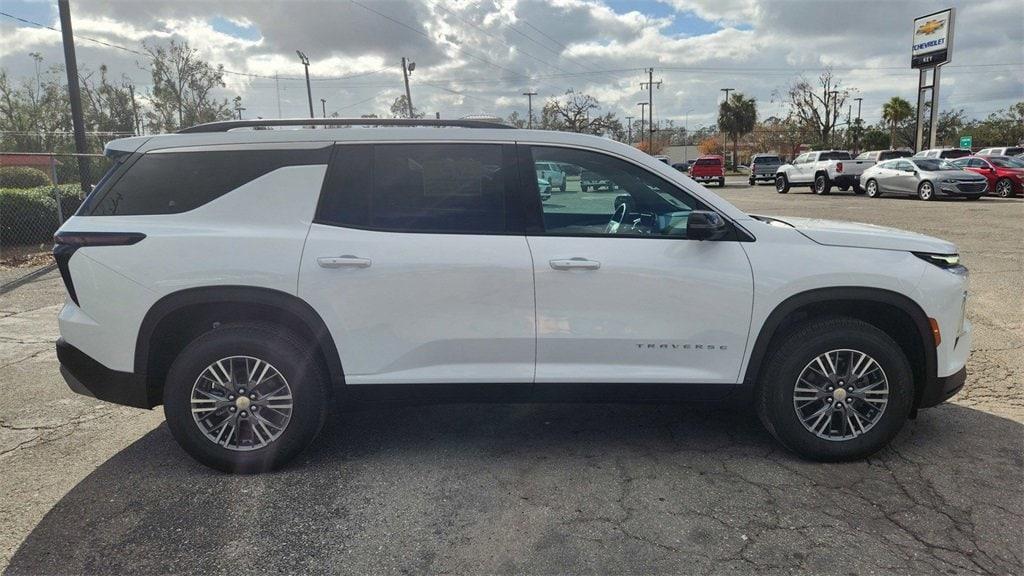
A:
[{"xmin": 134, "ymin": 286, "xmax": 345, "ymax": 398}]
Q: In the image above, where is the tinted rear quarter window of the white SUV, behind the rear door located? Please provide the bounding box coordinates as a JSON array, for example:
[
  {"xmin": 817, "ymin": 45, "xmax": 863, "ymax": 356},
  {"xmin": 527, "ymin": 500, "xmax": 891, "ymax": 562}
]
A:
[{"xmin": 89, "ymin": 147, "xmax": 331, "ymax": 216}]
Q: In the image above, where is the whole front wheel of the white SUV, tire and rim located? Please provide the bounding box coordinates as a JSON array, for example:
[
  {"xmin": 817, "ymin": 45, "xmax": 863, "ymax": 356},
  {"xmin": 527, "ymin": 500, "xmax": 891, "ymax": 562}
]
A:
[{"xmin": 757, "ymin": 317, "xmax": 914, "ymax": 461}]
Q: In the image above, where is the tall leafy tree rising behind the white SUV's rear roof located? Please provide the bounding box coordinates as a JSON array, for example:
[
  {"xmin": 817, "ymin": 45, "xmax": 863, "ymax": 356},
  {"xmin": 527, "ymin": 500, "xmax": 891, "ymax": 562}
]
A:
[{"xmin": 144, "ymin": 40, "xmax": 233, "ymax": 132}]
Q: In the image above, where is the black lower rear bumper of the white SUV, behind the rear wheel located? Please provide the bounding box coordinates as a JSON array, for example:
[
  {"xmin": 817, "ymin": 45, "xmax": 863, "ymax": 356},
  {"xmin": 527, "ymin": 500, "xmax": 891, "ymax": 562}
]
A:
[{"xmin": 56, "ymin": 338, "xmax": 160, "ymax": 408}]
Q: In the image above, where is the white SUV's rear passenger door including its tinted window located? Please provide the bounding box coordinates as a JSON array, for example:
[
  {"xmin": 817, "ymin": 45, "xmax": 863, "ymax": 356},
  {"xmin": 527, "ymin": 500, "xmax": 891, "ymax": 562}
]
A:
[{"xmin": 298, "ymin": 143, "xmax": 537, "ymax": 384}]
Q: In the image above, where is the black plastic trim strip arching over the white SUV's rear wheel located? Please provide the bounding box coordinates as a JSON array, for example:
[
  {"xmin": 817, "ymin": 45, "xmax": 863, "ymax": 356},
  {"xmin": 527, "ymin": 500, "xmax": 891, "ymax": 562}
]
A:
[{"xmin": 135, "ymin": 286, "xmax": 345, "ymax": 384}]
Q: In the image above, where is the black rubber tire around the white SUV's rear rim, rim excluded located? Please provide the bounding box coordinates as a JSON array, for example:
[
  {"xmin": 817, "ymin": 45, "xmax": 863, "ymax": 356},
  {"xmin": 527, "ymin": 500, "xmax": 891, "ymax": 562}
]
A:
[{"xmin": 164, "ymin": 324, "xmax": 330, "ymax": 474}]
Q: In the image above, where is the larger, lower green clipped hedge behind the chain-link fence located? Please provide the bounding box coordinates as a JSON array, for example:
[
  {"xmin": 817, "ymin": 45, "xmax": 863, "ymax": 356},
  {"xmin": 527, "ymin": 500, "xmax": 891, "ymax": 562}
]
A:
[{"xmin": 0, "ymin": 184, "xmax": 82, "ymax": 247}]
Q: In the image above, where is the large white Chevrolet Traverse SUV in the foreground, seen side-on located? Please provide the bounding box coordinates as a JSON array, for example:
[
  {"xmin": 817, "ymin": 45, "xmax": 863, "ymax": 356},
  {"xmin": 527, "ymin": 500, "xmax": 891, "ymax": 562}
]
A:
[{"xmin": 53, "ymin": 119, "xmax": 971, "ymax": 471}]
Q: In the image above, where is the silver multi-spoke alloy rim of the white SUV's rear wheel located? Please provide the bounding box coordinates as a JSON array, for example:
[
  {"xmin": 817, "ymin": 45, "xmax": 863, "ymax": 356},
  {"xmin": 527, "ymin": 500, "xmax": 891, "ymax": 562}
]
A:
[{"xmin": 190, "ymin": 356, "xmax": 294, "ymax": 452}]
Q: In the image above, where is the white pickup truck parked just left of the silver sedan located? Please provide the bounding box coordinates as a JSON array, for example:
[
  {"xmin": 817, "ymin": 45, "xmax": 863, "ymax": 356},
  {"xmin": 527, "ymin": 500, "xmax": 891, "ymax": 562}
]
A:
[{"xmin": 775, "ymin": 150, "xmax": 874, "ymax": 195}]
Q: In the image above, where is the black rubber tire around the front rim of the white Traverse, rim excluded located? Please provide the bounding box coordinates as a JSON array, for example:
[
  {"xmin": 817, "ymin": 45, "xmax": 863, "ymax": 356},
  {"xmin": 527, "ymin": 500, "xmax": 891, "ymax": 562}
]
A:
[{"xmin": 756, "ymin": 317, "xmax": 914, "ymax": 462}]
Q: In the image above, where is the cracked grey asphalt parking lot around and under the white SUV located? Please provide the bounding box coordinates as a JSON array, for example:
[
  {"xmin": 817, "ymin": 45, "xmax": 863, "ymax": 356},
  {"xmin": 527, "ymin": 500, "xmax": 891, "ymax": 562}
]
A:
[{"xmin": 0, "ymin": 177, "xmax": 1024, "ymax": 574}]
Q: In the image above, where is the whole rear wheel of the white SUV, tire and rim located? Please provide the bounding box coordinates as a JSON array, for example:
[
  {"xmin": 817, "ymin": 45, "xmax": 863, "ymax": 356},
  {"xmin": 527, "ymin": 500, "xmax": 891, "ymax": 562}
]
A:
[{"xmin": 164, "ymin": 324, "xmax": 329, "ymax": 474}]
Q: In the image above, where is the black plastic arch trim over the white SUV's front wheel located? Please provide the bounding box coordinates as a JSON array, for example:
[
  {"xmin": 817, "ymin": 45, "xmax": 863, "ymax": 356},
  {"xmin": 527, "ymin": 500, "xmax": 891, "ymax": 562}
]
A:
[{"xmin": 743, "ymin": 286, "xmax": 938, "ymax": 405}]
